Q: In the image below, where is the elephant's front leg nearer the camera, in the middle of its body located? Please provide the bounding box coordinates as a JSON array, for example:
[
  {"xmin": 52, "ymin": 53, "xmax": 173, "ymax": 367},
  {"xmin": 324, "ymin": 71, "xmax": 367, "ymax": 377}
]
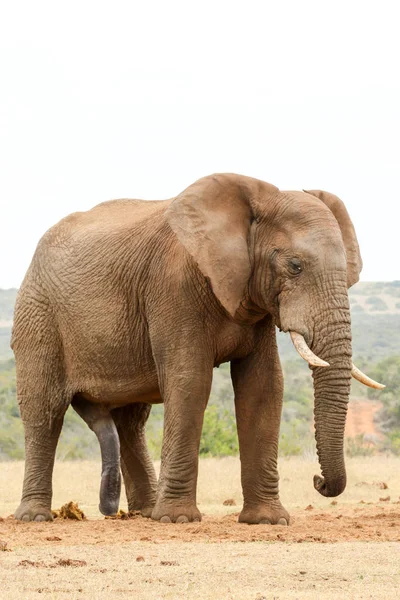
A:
[{"xmin": 151, "ymin": 364, "xmax": 212, "ymax": 523}]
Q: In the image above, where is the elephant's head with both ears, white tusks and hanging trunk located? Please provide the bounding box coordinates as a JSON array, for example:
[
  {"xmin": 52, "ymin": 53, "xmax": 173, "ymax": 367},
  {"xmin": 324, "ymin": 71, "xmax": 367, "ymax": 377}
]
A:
[{"xmin": 167, "ymin": 174, "xmax": 383, "ymax": 496}]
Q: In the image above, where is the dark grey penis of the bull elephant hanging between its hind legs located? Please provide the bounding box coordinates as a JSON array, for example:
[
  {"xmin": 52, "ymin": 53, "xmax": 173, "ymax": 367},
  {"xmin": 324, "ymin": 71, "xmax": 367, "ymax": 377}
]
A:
[{"xmin": 72, "ymin": 395, "xmax": 121, "ymax": 516}]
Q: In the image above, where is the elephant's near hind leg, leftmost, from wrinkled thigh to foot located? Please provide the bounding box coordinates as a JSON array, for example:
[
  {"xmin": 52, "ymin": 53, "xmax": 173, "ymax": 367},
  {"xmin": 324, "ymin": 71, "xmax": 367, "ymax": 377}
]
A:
[{"xmin": 12, "ymin": 310, "xmax": 72, "ymax": 521}]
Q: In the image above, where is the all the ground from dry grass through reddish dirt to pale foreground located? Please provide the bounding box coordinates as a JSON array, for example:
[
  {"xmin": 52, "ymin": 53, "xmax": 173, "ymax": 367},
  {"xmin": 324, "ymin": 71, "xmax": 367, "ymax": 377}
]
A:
[{"xmin": 0, "ymin": 457, "xmax": 400, "ymax": 600}]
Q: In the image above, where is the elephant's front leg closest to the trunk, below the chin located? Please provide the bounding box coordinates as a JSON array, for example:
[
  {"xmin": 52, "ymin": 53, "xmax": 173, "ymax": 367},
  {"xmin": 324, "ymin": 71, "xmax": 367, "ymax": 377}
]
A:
[{"xmin": 231, "ymin": 322, "xmax": 289, "ymax": 525}]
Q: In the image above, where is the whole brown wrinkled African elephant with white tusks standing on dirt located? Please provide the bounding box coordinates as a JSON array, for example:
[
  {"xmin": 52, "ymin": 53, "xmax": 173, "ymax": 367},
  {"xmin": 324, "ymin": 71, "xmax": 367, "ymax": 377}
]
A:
[{"xmin": 12, "ymin": 174, "xmax": 384, "ymax": 524}]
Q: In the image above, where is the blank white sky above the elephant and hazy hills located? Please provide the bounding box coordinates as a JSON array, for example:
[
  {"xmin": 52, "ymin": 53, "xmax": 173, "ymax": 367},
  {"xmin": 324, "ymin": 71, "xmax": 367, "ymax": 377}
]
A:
[{"xmin": 0, "ymin": 0, "xmax": 400, "ymax": 287}]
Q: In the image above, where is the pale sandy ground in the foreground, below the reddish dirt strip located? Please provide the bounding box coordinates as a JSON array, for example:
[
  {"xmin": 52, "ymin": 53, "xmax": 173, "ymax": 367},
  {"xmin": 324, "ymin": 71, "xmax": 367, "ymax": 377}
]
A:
[{"xmin": 0, "ymin": 540, "xmax": 400, "ymax": 600}]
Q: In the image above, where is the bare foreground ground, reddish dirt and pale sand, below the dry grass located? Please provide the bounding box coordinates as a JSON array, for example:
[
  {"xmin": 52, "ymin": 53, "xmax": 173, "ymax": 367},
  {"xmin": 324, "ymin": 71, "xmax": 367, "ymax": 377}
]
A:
[{"xmin": 0, "ymin": 502, "xmax": 400, "ymax": 600}]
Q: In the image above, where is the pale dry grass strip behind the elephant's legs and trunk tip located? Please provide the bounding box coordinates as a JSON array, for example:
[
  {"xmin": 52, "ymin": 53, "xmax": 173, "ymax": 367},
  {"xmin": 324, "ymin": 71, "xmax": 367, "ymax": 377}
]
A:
[{"xmin": 0, "ymin": 456, "xmax": 400, "ymax": 518}]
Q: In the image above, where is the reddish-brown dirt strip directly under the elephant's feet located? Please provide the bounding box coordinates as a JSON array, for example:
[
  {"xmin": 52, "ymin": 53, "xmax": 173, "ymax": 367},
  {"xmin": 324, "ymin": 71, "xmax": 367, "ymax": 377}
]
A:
[{"xmin": 0, "ymin": 502, "xmax": 400, "ymax": 550}]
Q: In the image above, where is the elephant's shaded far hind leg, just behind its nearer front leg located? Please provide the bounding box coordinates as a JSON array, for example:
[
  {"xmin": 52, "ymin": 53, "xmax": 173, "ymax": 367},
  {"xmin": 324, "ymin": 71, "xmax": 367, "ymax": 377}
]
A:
[{"xmin": 112, "ymin": 403, "xmax": 157, "ymax": 517}]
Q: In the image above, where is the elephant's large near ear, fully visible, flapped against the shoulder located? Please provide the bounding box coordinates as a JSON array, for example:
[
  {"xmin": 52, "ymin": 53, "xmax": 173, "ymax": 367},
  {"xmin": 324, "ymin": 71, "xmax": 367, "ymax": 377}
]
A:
[{"xmin": 166, "ymin": 174, "xmax": 276, "ymax": 316}]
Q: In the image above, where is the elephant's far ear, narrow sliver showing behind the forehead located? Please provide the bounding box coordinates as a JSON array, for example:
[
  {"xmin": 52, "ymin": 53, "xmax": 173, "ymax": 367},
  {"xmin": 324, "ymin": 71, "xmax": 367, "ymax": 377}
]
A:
[{"xmin": 303, "ymin": 190, "xmax": 362, "ymax": 287}]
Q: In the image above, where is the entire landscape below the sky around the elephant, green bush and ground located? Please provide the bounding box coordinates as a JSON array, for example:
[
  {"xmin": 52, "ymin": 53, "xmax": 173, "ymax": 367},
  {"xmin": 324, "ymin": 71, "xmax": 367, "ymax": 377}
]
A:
[{"xmin": 0, "ymin": 282, "xmax": 400, "ymax": 600}]
